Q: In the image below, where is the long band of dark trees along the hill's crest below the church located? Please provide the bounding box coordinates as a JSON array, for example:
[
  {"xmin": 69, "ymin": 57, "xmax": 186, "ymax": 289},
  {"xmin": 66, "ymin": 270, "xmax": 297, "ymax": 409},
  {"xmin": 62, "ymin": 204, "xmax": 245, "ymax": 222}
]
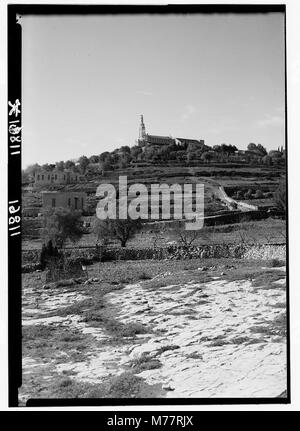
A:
[{"xmin": 22, "ymin": 142, "xmax": 285, "ymax": 182}]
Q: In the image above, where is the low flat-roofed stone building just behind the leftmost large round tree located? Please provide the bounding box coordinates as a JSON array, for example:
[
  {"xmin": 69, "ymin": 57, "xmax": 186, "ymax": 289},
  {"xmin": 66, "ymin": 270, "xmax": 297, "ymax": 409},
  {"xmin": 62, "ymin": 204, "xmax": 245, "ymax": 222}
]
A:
[{"xmin": 42, "ymin": 191, "xmax": 86, "ymax": 211}]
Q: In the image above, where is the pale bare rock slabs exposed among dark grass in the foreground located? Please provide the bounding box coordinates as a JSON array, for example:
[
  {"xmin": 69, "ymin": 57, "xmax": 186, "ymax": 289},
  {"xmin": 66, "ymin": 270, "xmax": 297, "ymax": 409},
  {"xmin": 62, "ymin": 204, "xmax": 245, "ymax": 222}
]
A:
[{"xmin": 23, "ymin": 268, "xmax": 286, "ymax": 398}]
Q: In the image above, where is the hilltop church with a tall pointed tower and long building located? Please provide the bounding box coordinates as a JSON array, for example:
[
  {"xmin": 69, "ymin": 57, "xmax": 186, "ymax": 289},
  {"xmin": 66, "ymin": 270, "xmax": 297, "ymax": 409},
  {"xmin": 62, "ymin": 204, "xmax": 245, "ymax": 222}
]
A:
[{"xmin": 137, "ymin": 115, "xmax": 206, "ymax": 150}]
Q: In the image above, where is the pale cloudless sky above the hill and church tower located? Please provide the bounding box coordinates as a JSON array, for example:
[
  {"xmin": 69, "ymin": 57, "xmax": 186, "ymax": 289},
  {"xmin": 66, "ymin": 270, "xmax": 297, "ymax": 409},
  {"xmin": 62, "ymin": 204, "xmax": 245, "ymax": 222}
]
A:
[{"xmin": 21, "ymin": 13, "xmax": 285, "ymax": 167}]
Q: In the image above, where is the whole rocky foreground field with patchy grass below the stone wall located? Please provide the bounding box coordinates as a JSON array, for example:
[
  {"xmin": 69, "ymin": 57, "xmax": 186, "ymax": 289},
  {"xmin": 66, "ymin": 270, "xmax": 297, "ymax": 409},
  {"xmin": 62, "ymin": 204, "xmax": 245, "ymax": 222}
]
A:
[{"xmin": 20, "ymin": 259, "xmax": 286, "ymax": 404}]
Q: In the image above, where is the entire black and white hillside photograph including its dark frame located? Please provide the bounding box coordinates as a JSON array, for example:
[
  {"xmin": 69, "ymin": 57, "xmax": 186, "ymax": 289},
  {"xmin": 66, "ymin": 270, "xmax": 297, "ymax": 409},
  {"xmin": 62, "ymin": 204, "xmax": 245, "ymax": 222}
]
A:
[{"xmin": 8, "ymin": 5, "xmax": 290, "ymax": 407}]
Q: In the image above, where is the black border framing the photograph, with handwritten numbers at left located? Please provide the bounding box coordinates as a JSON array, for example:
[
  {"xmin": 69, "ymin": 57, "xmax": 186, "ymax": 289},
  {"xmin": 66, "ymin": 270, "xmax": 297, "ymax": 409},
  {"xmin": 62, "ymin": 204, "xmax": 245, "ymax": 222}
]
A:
[{"xmin": 7, "ymin": 4, "xmax": 291, "ymax": 407}]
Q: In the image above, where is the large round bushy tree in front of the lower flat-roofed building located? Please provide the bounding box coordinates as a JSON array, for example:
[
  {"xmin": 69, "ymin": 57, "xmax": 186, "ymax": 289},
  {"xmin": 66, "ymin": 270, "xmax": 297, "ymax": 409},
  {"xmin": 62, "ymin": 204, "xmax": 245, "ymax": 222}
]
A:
[{"xmin": 42, "ymin": 208, "xmax": 84, "ymax": 248}]
